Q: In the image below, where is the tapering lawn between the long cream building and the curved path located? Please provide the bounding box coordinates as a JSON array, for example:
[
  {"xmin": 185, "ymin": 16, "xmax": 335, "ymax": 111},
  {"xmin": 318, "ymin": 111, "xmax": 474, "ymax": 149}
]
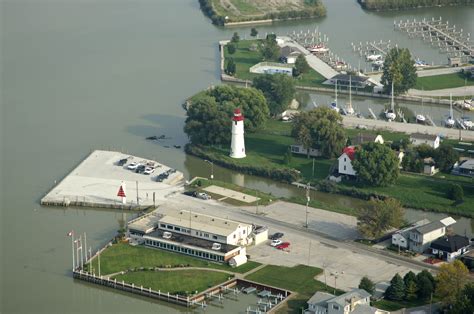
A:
[{"xmin": 87, "ymin": 243, "xmax": 261, "ymax": 275}]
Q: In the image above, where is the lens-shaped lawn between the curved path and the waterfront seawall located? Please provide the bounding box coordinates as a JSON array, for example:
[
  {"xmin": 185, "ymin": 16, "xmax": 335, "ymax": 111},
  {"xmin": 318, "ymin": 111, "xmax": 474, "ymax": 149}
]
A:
[{"xmin": 114, "ymin": 269, "xmax": 232, "ymax": 295}]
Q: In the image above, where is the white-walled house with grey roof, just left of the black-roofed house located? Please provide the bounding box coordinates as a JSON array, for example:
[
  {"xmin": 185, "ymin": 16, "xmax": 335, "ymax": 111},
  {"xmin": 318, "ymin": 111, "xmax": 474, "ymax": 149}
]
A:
[{"xmin": 408, "ymin": 221, "xmax": 446, "ymax": 253}]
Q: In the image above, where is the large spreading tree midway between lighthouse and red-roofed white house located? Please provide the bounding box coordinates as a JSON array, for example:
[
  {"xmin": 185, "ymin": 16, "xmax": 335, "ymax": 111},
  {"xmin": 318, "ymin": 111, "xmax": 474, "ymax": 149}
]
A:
[{"xmin": 291, "ymin": 107, "xmax": 347, "ymax": 158}]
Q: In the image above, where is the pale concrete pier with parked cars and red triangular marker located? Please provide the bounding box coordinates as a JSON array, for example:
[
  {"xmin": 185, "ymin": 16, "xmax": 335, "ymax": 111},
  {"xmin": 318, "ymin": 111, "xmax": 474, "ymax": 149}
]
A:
[{"xmin": 41, "ymin": 150, "xmax": 183, "ymax": 208}]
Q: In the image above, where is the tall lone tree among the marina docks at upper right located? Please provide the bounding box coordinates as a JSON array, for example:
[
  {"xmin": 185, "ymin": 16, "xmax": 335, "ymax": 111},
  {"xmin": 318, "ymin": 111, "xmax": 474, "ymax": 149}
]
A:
[{"xmin": 380, "ymin": 48, "xmax": 417, "ymax": 95}]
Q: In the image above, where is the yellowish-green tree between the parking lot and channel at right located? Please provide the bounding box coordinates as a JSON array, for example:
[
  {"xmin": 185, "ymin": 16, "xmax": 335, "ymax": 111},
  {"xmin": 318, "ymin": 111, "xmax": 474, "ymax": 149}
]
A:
[{"xmin": 357, "ymin": 198, "xmax": 404, "ymax": 238}]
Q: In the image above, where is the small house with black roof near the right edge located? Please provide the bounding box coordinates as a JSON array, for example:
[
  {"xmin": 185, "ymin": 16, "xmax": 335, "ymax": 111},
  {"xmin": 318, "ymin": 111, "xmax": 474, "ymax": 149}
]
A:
[{"xmin": 430, "ymin": 234, "xmax": 470, "ymax": 262}]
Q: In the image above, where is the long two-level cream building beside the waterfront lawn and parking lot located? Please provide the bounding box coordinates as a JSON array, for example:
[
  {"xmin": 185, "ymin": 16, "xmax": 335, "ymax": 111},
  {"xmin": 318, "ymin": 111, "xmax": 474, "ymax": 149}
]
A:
[{"xmin": 127, "ymin": 205, "xmax": 268, "ymax": 265}]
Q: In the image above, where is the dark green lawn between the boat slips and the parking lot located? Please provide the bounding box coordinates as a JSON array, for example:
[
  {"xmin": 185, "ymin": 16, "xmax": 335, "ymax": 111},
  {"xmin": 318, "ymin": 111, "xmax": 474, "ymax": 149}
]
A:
[{"xmin": 245, "ymin": 265, "xmax": 342, "ymax": 313}]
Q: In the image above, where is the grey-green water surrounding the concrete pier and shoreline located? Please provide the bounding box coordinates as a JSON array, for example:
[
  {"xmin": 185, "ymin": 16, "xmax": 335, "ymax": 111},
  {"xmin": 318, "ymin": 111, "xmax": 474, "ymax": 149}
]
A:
[{"xmin": 0, "ymin": 0, "xmax": 474, "ymax": 313}]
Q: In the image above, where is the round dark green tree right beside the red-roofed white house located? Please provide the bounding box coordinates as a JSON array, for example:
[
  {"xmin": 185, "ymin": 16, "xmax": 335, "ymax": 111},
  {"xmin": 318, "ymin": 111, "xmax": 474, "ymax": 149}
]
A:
[{"xmin": 352, "ymin": 142, "xmax": 400, "ymax": 186}]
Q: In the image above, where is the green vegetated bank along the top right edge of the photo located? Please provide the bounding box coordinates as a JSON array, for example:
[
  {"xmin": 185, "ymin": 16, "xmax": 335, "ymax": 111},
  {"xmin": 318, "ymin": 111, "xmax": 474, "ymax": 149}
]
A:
[{"xmin": 358, "ymin": 0, "xmax": 474, "ymax": 11}]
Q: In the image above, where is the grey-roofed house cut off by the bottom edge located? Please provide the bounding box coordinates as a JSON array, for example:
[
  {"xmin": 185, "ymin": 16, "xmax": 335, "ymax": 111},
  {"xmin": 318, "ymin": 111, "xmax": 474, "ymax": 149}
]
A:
[{"xmin": 305, "ymin": 289, "xmax": 389, "ymax": 314}]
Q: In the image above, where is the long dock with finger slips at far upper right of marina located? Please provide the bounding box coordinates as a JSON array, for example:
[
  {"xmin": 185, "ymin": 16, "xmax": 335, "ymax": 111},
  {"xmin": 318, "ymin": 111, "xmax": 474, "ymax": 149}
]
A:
[{"xmin": 394, "ymin": 17, "xmax": 474, "ymax": 65}]
